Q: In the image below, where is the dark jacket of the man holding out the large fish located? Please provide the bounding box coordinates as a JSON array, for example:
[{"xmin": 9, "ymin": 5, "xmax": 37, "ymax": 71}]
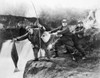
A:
[{"xmin": 17, "ymin": 27, "xmax": 44, "ymax": 47}]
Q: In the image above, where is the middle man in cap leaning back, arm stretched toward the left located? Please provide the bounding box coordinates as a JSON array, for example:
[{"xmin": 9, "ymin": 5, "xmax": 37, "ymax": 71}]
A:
[{"xmin": 52, "ymin": 19, "xmax": 73, "ymax": 58}]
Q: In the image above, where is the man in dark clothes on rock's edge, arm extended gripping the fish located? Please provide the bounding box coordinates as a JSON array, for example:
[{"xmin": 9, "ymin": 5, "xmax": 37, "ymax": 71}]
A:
[{"xmin": 14, "ymin": 20, "xmax": 49, "ymax": 61}]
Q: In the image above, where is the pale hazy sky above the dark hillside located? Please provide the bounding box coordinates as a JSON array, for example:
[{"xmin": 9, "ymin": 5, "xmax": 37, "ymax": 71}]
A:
[{"xmin": 0, "ymin": 0, "xmax": 100, "ymax": 17}]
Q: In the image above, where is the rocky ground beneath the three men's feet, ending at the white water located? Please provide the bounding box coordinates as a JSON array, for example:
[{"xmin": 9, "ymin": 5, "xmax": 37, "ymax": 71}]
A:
[{"xmin": 23, "ymin": 50, "xmax": 100, "ymax": 78}]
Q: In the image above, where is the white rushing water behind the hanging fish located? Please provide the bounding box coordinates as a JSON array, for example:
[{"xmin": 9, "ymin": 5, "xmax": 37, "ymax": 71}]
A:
[{"xmin": 0, "ymin": 40, "xmax": 33, "ymax": 78}]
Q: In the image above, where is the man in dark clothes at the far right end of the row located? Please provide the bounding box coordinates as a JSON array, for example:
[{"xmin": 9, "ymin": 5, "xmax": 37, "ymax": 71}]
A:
[{"xmin": 73, "ymin": 21, "xmax": 85, "ymax": 59}]
